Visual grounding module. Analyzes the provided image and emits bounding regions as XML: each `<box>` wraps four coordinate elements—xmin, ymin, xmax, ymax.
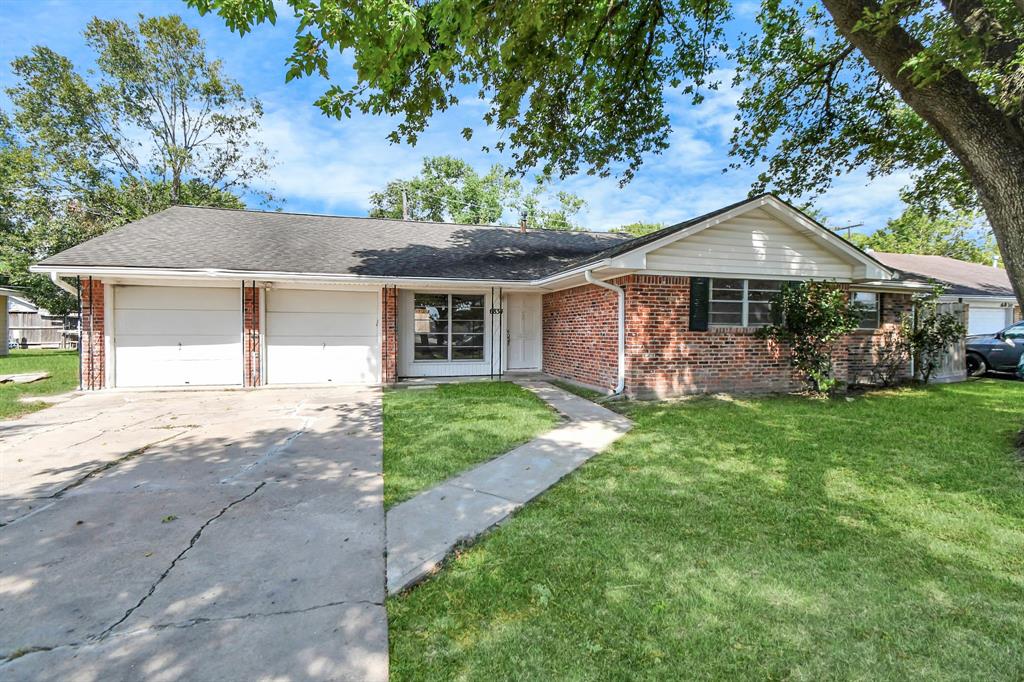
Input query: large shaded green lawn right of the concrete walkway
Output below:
<box><xmin>388</xmin><ymin>380</ymin><xmax>1024</xmax><ymax>680</ymax></box>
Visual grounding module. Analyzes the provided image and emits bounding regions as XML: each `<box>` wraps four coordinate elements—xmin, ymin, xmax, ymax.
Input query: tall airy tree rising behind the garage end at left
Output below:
<box><xmin>0</xmin><ymin>16</ymin><xmax>270</xmax><ymax>312</ymax></box>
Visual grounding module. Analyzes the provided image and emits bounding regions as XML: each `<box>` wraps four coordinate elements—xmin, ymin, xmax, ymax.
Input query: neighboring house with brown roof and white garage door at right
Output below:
<box><xmin>871</xmin><ymin>251</ymin><xmax>1021</xmax><ymax>335</ymax></box>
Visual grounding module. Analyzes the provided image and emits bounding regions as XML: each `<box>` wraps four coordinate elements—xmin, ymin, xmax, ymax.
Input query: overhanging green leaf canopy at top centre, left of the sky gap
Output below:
<box><xmin>189</xmin><ymin>0</ymin><xmax>729</xmax><ymax>180</ymax></box>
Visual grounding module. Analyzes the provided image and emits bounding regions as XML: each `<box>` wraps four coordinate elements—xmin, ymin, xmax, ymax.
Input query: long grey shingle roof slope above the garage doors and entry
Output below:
<box><xmin>40</xmin><ymin>206</ymin><xmax>631</xmax><ymax>281</ymax></box>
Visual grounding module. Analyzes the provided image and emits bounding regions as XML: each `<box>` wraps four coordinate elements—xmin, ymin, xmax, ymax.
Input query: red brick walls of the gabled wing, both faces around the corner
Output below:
<box><xmin>544</xmin><ymin>275</ymin><xmax>911</xmax><ymax>397</ymax></box>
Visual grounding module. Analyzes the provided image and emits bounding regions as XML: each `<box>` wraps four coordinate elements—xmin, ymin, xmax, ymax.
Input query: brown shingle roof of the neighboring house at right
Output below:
<box><xmin>871</xmin><ymin>251</ymin><xmax>1014</xmax><ymax>296</ymax></box>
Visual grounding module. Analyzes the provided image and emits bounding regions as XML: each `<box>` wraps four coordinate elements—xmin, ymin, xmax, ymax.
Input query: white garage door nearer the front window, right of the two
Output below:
<box><xmin>266</xmin><ymin>289</ymin><xmax>380</xmax><ymax>384</ymax></box>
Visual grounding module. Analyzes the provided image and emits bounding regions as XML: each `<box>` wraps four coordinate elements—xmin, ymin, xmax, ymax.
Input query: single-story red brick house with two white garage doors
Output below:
<box><xmin>33</xmin><ymin>195</ymin><xmax>927</xmax><ymax>396</ymax></box>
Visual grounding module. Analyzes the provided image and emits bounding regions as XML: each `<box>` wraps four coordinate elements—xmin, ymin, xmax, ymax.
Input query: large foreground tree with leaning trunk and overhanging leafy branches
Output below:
<box><xmin>188</xmin><ymin>0</ymin><xmax>1024</xmax><ymax>298</ymax></box>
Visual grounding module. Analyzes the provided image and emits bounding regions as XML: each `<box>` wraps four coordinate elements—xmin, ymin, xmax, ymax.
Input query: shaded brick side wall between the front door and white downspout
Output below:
<box><xmin>543</xmin><ymin>285</ymin><xmax>618</xmax><ymax>390</ymax></box>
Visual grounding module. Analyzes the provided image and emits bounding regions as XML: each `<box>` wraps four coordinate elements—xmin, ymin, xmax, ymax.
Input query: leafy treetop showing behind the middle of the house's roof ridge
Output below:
<box><xmin>370</xmin><ymin>156</ymin><xmax>585</xmax><ymax>230</ymax></box>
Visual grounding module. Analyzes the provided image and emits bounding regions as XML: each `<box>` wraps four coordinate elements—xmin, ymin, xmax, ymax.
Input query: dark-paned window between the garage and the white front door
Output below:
<box><xmin>413</xmin><ymin>294</ymin><xmax>484</xmax><ymax>361</ymax></box>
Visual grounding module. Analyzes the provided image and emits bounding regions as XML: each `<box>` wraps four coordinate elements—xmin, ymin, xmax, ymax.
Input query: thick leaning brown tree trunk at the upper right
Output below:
<box><xmin>823</xmin><ymin>0</ymin><xmax>1024</xmax><ymax>302</ymax></box>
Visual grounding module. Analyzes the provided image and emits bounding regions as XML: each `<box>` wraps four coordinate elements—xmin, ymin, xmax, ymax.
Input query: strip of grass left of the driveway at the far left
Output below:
<box><xmin>0</xmin><ymin>350</ymin><xmax>78</xmax><ymax>419</ymax></box>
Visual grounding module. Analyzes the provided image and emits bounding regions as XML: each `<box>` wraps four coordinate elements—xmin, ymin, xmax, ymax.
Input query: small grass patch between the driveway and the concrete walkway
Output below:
<box><xmin>384</xmin><ymin>382</ymin><xmax>558</xmax><ymax>507</ymax></box>
